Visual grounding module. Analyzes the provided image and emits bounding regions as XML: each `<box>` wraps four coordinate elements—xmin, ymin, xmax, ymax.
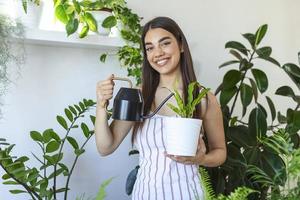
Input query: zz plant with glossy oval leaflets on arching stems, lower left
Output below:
<box><xmin>0</xmin><ymin>99</ymin><xmax>95</xmax><ymax>200</ymax></box>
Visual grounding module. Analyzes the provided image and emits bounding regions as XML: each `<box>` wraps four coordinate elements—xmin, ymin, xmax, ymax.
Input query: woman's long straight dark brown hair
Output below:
<box><xmin>131</xmin><ymin>17</ymin><xmax>200</xmax><ymax>144</ymax></box>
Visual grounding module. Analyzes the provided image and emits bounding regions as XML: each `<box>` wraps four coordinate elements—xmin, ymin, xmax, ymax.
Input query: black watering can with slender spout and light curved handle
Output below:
<box><xmin>112</xmin><ymin>77</ymin><xmax>174</xmax><ymax>122</ymax></box>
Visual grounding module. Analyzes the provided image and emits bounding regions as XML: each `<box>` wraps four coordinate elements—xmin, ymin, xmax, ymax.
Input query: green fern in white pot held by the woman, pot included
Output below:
<box><xmin>165</xmin><ymin>82</ymin><xmax>209</xmax><ymax>156</ymax></box>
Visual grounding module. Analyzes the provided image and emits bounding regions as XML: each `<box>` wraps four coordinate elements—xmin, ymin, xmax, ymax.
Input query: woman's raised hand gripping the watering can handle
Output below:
<box><xmin>96</xmin><ymin>74</ymin><xmax>115</xmax><ymax>108</ymax></box>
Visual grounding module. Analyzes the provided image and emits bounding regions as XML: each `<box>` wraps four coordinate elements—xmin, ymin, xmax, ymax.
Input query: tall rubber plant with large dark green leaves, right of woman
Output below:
<box><xmin>209</xmin><ymin>24</ymin><xmax>300</xmax><ymax>199</ymax></box>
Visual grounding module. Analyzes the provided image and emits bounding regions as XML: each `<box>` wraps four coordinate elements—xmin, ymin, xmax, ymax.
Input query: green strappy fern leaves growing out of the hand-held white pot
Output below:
<box><xmin>167</xmin><ymin>81</ymin><xmax>210</xmax><ymax>118</ymax></box>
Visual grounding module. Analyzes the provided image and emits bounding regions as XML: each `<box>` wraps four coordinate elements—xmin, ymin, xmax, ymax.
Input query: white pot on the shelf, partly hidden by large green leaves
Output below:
<box><xmin>89</xmin><ymin>10</ymin><xmax>112</xmax><ymax>36</ymax></box>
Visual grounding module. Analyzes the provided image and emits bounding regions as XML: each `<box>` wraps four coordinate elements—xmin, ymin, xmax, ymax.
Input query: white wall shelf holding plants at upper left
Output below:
<box><xmin>25</xmin><ymin>28</ymin><xmax>125</xmax><ymax>50</ymax></box>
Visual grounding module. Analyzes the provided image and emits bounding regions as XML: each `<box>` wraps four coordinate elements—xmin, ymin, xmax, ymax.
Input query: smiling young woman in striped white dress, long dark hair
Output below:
<box><xmin>95</xmin><ymin>17</ymin><xmax>226</xmax><ymax>200</ymax></box>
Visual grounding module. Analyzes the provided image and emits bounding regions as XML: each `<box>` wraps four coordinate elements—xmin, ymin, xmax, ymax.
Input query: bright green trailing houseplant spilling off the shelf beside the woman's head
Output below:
<box><xmin>54</xmin><ymin>0</ymin><xmax>143</xmax><ymax>84</ymax></box>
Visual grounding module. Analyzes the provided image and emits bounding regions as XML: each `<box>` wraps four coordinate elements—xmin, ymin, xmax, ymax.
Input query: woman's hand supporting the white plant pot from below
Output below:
<box><xmin>165</xmin><ymin>136</ymin><xmax>206</xmax><ymax>165</ymax></box>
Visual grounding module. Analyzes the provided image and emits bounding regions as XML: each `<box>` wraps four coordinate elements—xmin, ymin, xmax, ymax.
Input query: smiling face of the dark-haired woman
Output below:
<box><xmin>144</xmin><ymin>28</ymin><xmax>180</xmax><ymax>75</ymax></box>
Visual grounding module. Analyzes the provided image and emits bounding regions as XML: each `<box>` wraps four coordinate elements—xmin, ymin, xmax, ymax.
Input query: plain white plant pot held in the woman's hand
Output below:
<box><xmin>164</xmin><ymin>117</ymin><xmax>202</xmax><ymax>156</ymax></box>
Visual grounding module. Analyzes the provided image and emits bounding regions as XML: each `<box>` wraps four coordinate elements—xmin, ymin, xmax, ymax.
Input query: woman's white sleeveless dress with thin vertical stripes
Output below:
<box><xmin>132</xmin><ymin>115</ymin><xmax>204</xmax><ymax>200</ymax></box>
